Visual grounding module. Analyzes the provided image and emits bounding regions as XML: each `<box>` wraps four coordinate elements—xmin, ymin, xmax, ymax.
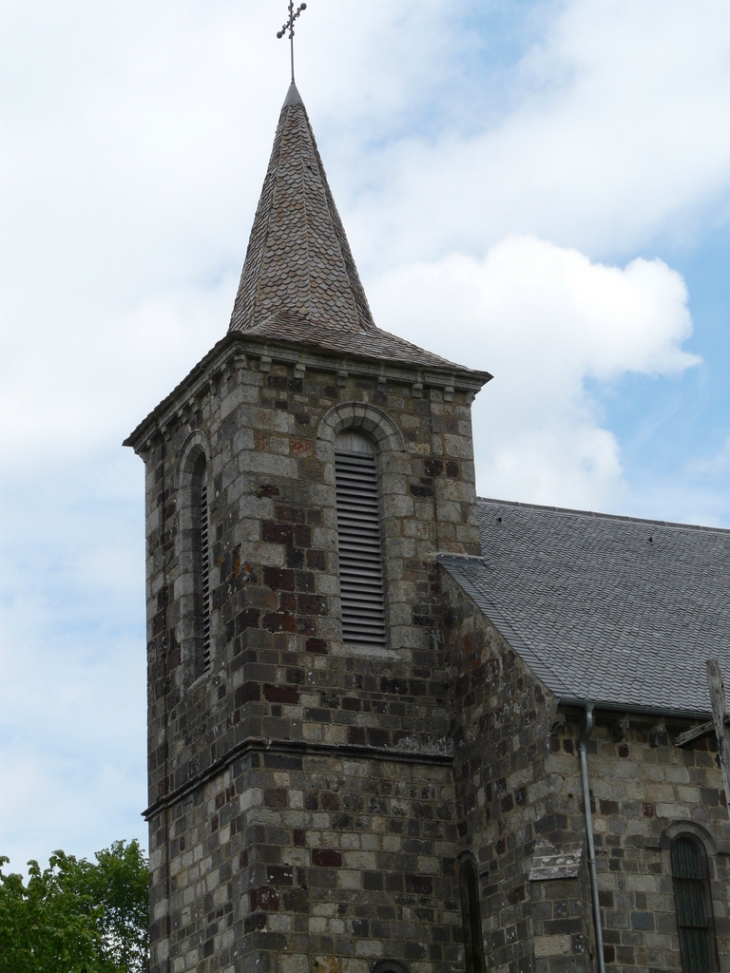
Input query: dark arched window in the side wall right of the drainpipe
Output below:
<box><xmin>671</xmin><ymin>834</ymin><xmax>718</xmax><ymax>973</ymax></box>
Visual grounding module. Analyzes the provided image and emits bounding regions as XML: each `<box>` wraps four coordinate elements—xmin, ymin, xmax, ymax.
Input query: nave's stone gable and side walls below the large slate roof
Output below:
<box><xmin>444</xmin><ymin>578</ymin><xmax>730</xmax><ymax>973</ymax></box>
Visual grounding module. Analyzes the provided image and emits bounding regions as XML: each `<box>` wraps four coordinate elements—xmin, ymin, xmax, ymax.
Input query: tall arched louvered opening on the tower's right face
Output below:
<box><xmin>335</xmin><ymin>430</ymin><xmax>386</xmax><ymax>648</ymax></box>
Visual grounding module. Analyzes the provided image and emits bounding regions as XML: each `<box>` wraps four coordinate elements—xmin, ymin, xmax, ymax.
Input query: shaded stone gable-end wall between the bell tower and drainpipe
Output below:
<box><xmin>444</xmin><ymin>577</ymin><xmax>595</xmax><ymax>973</ymax></box>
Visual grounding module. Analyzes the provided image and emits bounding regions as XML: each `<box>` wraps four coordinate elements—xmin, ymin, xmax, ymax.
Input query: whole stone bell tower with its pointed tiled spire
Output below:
<box><xmin>125</xmin><ymin>84</ymin><xmax>489</xmax><ymax>973</ymax></box>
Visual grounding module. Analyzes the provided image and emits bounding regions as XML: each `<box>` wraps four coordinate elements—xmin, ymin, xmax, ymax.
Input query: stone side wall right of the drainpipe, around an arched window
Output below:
<box><xmin>547</xmin><ymin>711</ymin><xmax>730</xmax><ymax>973</ymax></box>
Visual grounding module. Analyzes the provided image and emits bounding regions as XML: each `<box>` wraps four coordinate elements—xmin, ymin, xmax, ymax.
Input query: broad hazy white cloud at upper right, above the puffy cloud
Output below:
<box><xmin>360</xmin><ymin>0</ymin><xmax>730</xmax><ymax>268</ymax></box>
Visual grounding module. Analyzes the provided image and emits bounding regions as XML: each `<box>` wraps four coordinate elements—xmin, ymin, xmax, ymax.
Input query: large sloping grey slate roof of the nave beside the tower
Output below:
<box><xmin>439</xmin><ymin>499</ymin><xmax>730</xmax><ymax>717</ymax></box>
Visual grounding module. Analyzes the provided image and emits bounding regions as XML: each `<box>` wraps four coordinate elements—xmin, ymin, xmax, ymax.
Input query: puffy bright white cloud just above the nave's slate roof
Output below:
<box><xmin>372</xmin><ymin>237</ymin><xmax>698</xmax><ymax>509</ymax></box>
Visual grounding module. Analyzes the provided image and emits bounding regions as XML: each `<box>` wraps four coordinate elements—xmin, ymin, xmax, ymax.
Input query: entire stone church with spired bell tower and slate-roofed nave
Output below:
<box><xmin>125</xmin><ymin>83</ymin><xmax>730</xmax><ymax>973</ymax></box>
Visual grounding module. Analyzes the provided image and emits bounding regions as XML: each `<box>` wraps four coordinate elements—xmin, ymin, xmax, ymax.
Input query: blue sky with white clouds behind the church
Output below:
<box><xmin>0</xmin><ymin>0</ymin><xmax>730</xmax><ymax>870</ymax></box>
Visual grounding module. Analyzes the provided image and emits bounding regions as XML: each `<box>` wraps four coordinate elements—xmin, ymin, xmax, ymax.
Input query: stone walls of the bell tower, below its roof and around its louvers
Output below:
<box><xmin>134</xmin><ymin>342</ymin><xmax>479</xmax><ymax>973</ymax></box>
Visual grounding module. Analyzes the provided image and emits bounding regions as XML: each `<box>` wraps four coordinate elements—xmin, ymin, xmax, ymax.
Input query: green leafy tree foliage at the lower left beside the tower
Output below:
<box><xmin>0</xmin><ymin>841</ymin><xmax>149</xmax><ymax>973</ymax></box>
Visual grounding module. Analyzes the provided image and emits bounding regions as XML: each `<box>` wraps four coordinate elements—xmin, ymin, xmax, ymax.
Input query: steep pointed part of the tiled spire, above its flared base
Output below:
<box><xmin>230</xmin><ymin>88</ymin><xmax>377</xmax><ymax>337</ymax></box>
